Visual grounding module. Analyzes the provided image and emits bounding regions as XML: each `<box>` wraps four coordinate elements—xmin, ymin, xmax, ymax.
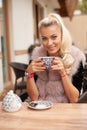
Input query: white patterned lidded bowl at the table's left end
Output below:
<box><xmin>2</xmin><ymin>90</ymin><xmax>22</xmax><ymax>112</ymax></box>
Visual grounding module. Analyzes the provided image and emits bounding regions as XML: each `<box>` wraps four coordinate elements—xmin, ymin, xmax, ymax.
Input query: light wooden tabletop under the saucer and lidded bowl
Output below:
<box><xmin>0</xmin><ymin>102</ymin><xmax>87</xmax><ymax>130</ymax></box>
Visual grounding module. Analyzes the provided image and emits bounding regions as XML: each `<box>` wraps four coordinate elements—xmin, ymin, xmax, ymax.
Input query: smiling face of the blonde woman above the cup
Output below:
<box><xmin>40</xmin><ymin>24</ymin><xmax>62</xmax><ymax>56</ymax></box>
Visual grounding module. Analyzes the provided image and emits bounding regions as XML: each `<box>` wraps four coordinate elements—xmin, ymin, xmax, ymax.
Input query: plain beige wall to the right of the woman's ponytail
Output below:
<box><xmin>64</xmin><ymin>15</ymin><xmax>87</xmax><ymax>52</ymax></box>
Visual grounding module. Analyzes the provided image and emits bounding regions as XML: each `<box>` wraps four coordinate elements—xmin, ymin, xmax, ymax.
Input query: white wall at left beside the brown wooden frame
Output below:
<box><xmin>9</xmin><ymin>0</ymin><xmax>34</xmax><ymax>62</ymax></box>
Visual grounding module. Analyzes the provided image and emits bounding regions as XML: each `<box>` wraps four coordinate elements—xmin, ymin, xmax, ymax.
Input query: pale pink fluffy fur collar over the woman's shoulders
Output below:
<box><xmin>31</xmin><ymin>46</ymin><xmax>86</xmax><ymax>77</ymax></box>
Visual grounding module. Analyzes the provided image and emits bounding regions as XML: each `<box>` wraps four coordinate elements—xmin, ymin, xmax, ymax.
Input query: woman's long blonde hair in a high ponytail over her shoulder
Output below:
<box><xmin>38</xmin><ymin>13</ymin><xmax>74</xmax><ymax>68</ymax></box>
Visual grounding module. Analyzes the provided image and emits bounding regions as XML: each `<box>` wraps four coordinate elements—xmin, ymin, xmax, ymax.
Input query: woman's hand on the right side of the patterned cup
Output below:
<box><xmin>51</xmin><ymin>57</ymin><xmax>66</xmax><ymax>76</ymax></box>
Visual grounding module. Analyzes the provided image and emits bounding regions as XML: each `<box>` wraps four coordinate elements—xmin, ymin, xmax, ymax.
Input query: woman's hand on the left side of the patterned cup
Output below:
<box><xmin>26</xmin><ymin>58</ymin><xmax>45</xmax><ymax>73</ymax></box>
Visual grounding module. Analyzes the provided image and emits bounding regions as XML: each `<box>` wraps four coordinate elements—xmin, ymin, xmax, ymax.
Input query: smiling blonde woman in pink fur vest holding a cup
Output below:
<box><xmin>26</xmin><ymin>13</ymin><xmax>85</xmax><ymax>103</ymax></box>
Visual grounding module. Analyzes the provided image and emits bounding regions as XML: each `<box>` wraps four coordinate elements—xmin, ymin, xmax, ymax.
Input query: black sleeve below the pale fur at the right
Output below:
<box><xmin>72</xmin><ymin>61</ymin><xmax>84</xmax><ymax>92</ymax></box>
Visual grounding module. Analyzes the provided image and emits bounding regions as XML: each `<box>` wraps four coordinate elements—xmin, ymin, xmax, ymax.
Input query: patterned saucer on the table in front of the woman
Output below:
<box><xmin>28</xmin><ymin>100</ymin><xmax>53</xmax><ymax>110</ymax></box>
